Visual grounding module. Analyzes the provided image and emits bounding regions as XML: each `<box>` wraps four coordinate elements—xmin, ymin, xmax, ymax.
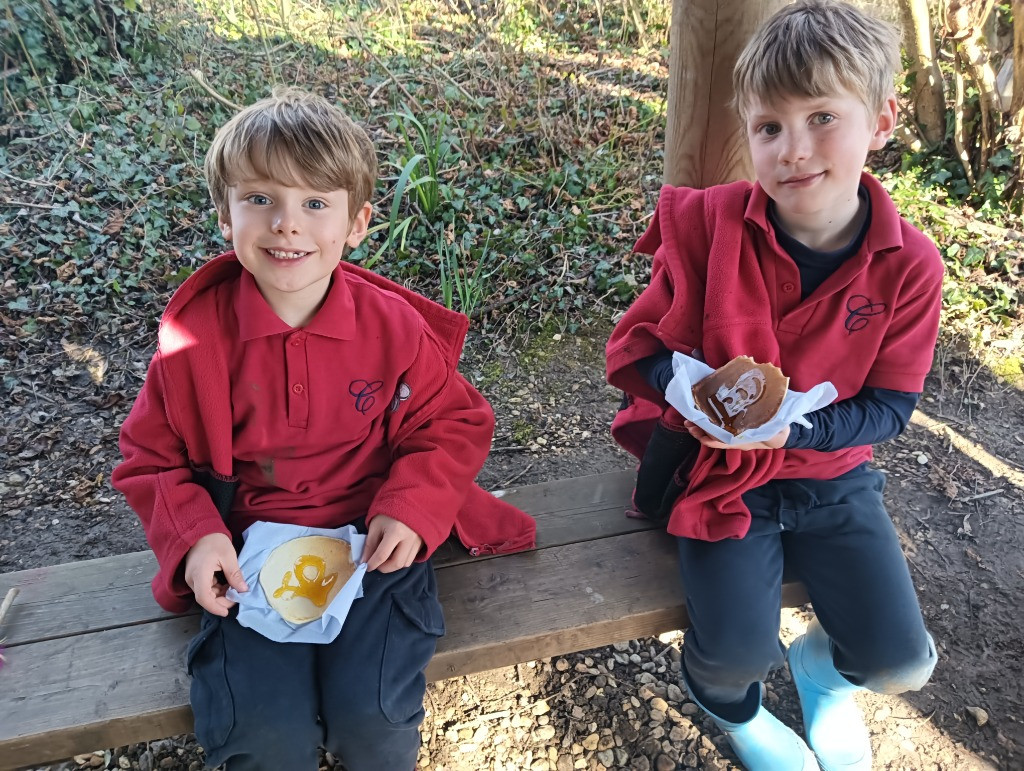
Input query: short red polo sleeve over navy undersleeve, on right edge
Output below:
<box><xmin>864</xmin><ymin>246</ymin><xmax>943</xmax><ymax>392</ymax></box>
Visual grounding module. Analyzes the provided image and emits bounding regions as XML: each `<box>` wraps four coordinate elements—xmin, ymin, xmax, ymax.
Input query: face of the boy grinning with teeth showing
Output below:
<box><xmin>218</xmin><ymin>178</ymin><xmax>371</xmax><ymax>327</ymax></box>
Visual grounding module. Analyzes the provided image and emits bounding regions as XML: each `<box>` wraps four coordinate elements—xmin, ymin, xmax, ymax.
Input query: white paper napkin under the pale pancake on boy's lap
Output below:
<box><xmin>226</xmin><ymin>522</ymin><xmax>367</xmax><ymax>643</ymax></box>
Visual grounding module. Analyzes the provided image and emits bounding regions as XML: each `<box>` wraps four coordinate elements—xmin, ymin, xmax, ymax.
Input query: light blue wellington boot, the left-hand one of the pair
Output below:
<box><xmin>684</xmin><ymin>678</ymin><xmax>818</xmax><ymax>771</ymax></box>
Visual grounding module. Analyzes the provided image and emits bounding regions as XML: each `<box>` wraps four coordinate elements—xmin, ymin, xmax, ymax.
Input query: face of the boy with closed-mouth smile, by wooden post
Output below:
<box><xmin>746</xmin><ymin>91</ymin><xmax>896</xmax><ymax>243</ymax></box>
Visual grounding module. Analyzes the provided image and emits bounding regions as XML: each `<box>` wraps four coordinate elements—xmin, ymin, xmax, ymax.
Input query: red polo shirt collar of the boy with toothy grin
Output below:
<box><xmin>234</xmin><ymin>262</ymin><xmax>355</xmax><ymax>341</ymax></box>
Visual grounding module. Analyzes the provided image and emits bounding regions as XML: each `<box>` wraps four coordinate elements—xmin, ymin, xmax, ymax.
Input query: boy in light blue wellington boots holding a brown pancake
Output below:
<box><xmin>607</xmin><ymin>0</ymin><xmax>943</xmax><ymax>771</ymax></box>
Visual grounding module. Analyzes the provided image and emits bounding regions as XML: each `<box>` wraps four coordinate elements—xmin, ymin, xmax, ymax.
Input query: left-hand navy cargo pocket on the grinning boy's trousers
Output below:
<box><xmin>185</xmin><ymin>611</ymin><xmax>234</xmax><ymax>753</ymax></box>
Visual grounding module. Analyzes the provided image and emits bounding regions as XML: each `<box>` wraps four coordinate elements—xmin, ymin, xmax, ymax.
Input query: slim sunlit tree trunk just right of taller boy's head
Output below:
<box><xmin>899</xmin><ymin>0</ymin><xmax>946</xmax><ymax>147</ymax></box>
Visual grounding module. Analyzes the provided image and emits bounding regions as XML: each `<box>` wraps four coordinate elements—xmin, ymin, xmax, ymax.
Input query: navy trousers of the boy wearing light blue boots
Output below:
<box><xmin>677</xmin><ymin>464</ymin><xmax>936</xmax><ymax>723</ymax></box>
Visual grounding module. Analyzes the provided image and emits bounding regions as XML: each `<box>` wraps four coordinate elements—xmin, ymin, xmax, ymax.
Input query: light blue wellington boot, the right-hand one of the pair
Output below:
<box><xmin>787</xmin><ymin>618</ymin><xmax>871</xmax><ymax>771</ymax></box>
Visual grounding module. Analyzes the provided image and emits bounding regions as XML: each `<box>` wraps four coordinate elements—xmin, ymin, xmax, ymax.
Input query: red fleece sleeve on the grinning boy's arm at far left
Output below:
<box><xmin>111</xmin><ymin>351</ymin><xmax>230</xmax><ymax>612</ymax></box>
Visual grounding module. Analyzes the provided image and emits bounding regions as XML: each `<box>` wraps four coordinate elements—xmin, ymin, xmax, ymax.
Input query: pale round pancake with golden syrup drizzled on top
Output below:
<box><xmin>259</xmin><ymin>536</ymin><xmax>355</xmax><ymax>624</ymax></box>
